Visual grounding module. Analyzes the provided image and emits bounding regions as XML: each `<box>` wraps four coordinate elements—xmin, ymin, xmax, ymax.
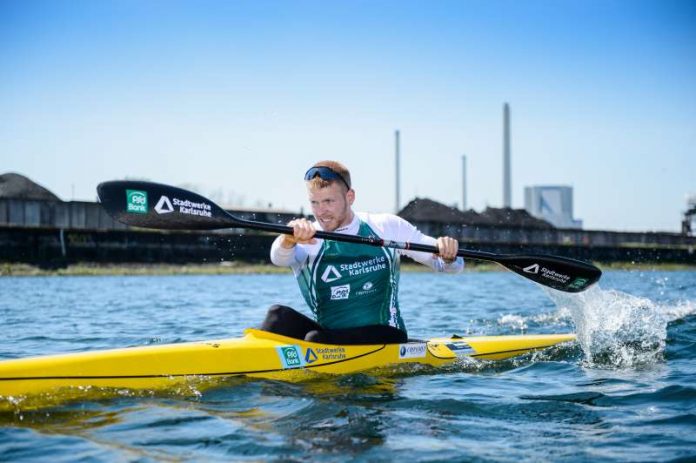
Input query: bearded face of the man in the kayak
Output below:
<box><xmin>307</xmin><ymin>182</ymin><xmax>355</xmax><ymax>231</ymax></box>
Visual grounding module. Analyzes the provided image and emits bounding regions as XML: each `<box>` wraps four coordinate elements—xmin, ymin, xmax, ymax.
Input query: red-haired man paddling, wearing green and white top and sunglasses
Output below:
<box><xmin>261</xmin><ymin>161</ymin><xmax>464</xmax><ymax>344</ymax></box>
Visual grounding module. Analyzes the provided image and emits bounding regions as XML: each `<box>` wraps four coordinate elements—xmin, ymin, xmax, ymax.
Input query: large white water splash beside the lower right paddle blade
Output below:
<box><xmin>547</xmin><ymin>285</ymin><xmax>696</xmax><ymax>368</ymax></box>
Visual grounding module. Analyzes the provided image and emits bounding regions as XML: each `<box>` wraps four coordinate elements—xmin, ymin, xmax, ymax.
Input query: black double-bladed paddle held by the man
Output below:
<box><xmin>97</xmin><ymin>180</ymin><xmax>602</xmax><ymax>293</ymax></box>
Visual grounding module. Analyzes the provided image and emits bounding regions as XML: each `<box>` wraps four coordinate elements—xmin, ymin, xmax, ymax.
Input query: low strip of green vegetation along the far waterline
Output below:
<box><xmin>0</xmin><ymin>261</ymin><xmax>696</xmax><ymax>276</ymax></box>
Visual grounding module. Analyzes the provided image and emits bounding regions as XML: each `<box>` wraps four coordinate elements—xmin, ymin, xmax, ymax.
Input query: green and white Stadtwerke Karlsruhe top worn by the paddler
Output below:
<box><xmin>271</xmin><ymin>213</ymin><xmax>464</xmax><ymax>331</ymax></box>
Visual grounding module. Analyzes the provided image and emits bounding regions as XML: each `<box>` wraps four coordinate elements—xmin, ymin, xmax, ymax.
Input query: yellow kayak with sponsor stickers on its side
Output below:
<box><xmin>0</xmin><ymin>329</ymin><xmax>575</xmax><ymax>400</ymax></box>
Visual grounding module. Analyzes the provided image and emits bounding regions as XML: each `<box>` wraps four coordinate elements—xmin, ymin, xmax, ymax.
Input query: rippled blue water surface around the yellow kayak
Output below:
<box><xmin>0</xmin><ymin>271</ymin><xmax>696</xmax><ymax>462</ymax></box>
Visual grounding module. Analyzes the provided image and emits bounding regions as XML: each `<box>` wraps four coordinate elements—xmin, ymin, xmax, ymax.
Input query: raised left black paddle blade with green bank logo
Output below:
<box><xmin>97</xmin><ymin>180</ymin><xmax>236</xmax><ymax>230</ymax></box>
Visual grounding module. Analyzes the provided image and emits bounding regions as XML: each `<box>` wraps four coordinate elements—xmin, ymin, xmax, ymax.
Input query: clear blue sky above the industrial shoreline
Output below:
<box><xmin>0</xmin><ymin>0</ymin><xmax>696</xmax><ymax>231</ymax></box>
